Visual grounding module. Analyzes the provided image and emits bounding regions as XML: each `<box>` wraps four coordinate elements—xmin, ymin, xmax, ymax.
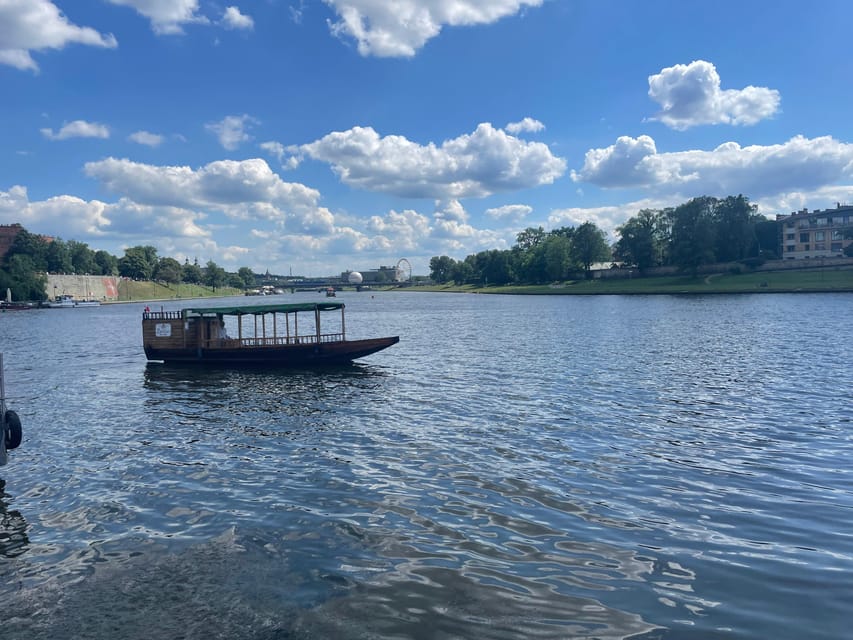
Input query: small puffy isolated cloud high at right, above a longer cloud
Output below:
<box><xmin>649</xmin><ymin>60</ymin><xmax>780</xmax><ymax>130</ymax></box>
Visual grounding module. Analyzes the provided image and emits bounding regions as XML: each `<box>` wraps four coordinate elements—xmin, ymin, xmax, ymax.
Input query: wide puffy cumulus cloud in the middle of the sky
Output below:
<box><xmin>288</xmin><ymin>123</ymin><xmax>566</xmax><ymax>199</ymax></box>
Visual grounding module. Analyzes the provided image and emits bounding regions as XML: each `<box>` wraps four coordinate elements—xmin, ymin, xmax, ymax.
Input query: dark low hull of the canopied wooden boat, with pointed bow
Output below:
<box><xmin>144</xmin><ymin>336</ymin><xmax>400</xmax><ymax>367</ymax></box>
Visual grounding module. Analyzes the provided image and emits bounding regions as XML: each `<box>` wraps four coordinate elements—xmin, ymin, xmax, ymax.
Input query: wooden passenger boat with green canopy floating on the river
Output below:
<box><xmin>142</xmin><ymin>301</ymin><xmax>400</xmax><ymax>366</ymax></box>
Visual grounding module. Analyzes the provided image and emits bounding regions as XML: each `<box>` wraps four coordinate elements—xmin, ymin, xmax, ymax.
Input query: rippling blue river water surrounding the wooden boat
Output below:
<box><xmin>0</xmin><ymin>292</ymin><xmax>853</xmax><ymax>640</ymax></box>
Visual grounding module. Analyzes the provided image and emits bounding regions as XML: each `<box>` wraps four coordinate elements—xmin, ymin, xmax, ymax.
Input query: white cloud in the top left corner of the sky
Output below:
<box><xmin>0</xmin><ymin>0</ymin><xmax>118</xmax><ymax>71</ymax></box>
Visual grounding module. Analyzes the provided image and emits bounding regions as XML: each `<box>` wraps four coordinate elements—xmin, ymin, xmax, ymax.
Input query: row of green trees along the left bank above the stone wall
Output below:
<box><xmin>0</xmin><ymin>229</ymin><xmax>255</xmax><ymax>300</ymax></box>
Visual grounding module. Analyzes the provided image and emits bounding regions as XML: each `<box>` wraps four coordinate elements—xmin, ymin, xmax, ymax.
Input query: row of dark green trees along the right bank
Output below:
<box><xmin>429</xmin><ymin>195</ymin><xmax>779</xmax><ymax>285</ymax></box>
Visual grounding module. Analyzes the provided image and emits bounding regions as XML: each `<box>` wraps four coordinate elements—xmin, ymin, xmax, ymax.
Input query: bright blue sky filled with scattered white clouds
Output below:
<box><xmin>0</xmin><ymin>0</ymin><xmax>853</xmax><ymax>276</ymax></box>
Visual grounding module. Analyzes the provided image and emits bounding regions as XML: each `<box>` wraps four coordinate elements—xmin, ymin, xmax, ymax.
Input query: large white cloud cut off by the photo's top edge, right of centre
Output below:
<box><xmin>324</xmin><ymin>0</ymin><xmax>543</xmax><ymax>57</ymax></box>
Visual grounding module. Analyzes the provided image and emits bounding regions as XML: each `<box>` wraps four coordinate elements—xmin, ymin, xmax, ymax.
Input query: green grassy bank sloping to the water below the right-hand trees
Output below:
<box><xmin>408</xmin><ymin>267</ymin><xmax>853</xmax><ymax>295</ymax></box>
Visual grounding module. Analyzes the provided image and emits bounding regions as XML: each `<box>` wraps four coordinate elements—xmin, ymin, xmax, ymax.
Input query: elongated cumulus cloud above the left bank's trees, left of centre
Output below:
<box><xmin>80</xmin><ymin>158</ymin><xmax>334</xmax><ymax>233</ymax></box>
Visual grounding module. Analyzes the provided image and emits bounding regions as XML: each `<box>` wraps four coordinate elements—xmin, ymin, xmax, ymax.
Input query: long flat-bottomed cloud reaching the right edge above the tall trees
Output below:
<box><xmin>571</xmin><ymin>136</ymin><xmax>853</xmax><ymax>198</ymax></box>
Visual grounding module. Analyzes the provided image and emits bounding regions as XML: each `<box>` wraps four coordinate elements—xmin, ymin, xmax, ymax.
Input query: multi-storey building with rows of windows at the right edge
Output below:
<box><xmin>776</xmin><ymin>202</ymin><xmax>853</xmax><ymax>260</ymax></box>
